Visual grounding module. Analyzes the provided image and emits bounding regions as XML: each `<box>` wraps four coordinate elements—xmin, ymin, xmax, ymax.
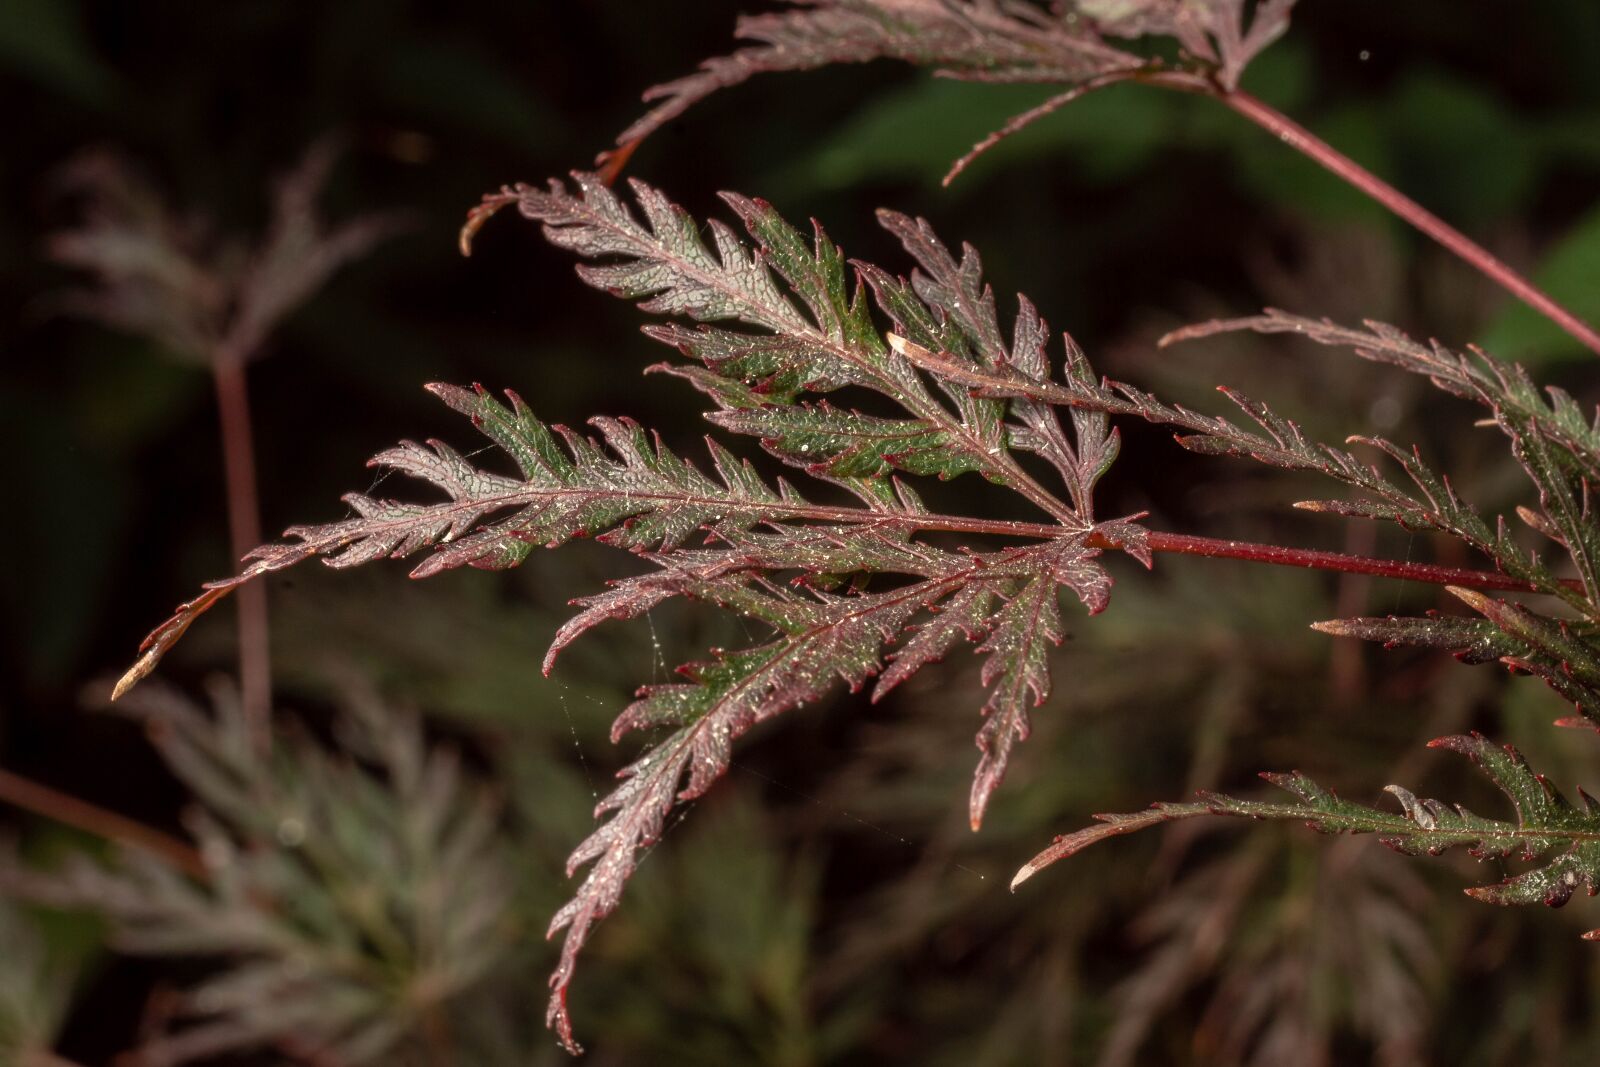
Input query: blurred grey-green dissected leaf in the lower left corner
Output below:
<box><xmin>0</xmin><ymin>689</ymin><xmax>518</xmax><ymax>1065</ymax></box>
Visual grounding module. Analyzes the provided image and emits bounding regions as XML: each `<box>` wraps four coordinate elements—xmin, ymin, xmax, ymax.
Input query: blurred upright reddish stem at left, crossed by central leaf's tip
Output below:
<box><xmin>211</xmin><ymin>352</ymin><xmax>272</xmax><ymax>750</ymax></box>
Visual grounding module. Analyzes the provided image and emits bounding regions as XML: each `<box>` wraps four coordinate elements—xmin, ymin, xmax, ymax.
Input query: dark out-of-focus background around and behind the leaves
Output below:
<box><xmin>9</xmin><ymin>0</ymin><xmax>1600</xmax><ymax>1065</ymax></box>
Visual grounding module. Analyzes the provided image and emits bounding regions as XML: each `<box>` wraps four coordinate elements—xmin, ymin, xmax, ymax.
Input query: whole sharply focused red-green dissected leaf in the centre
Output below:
<box><xmin>128</xmin><ymin>174</ymin><xmax>1177</xmax><ymax>1048</ymax></box>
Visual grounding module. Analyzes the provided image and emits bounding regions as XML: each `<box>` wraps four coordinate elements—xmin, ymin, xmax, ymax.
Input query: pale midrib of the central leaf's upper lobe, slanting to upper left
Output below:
<box><xmin>540</xmin><ymin>184</ymin><xmax>1077</xmax><ymax>523</ymax></box>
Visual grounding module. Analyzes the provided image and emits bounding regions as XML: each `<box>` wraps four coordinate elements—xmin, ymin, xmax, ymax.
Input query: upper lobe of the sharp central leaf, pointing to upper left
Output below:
<box><xmin>485</xmin><ymin>174</ymin><xmax>1070</xmax><ymax>518</ymax></box>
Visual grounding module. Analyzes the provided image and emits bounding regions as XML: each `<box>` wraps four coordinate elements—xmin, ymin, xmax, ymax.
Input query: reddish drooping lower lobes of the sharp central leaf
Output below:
<box><xmin>547</xmin><ymin>534</ymin><xmax>1110</xmax><ymax>1049</ymax></box>
